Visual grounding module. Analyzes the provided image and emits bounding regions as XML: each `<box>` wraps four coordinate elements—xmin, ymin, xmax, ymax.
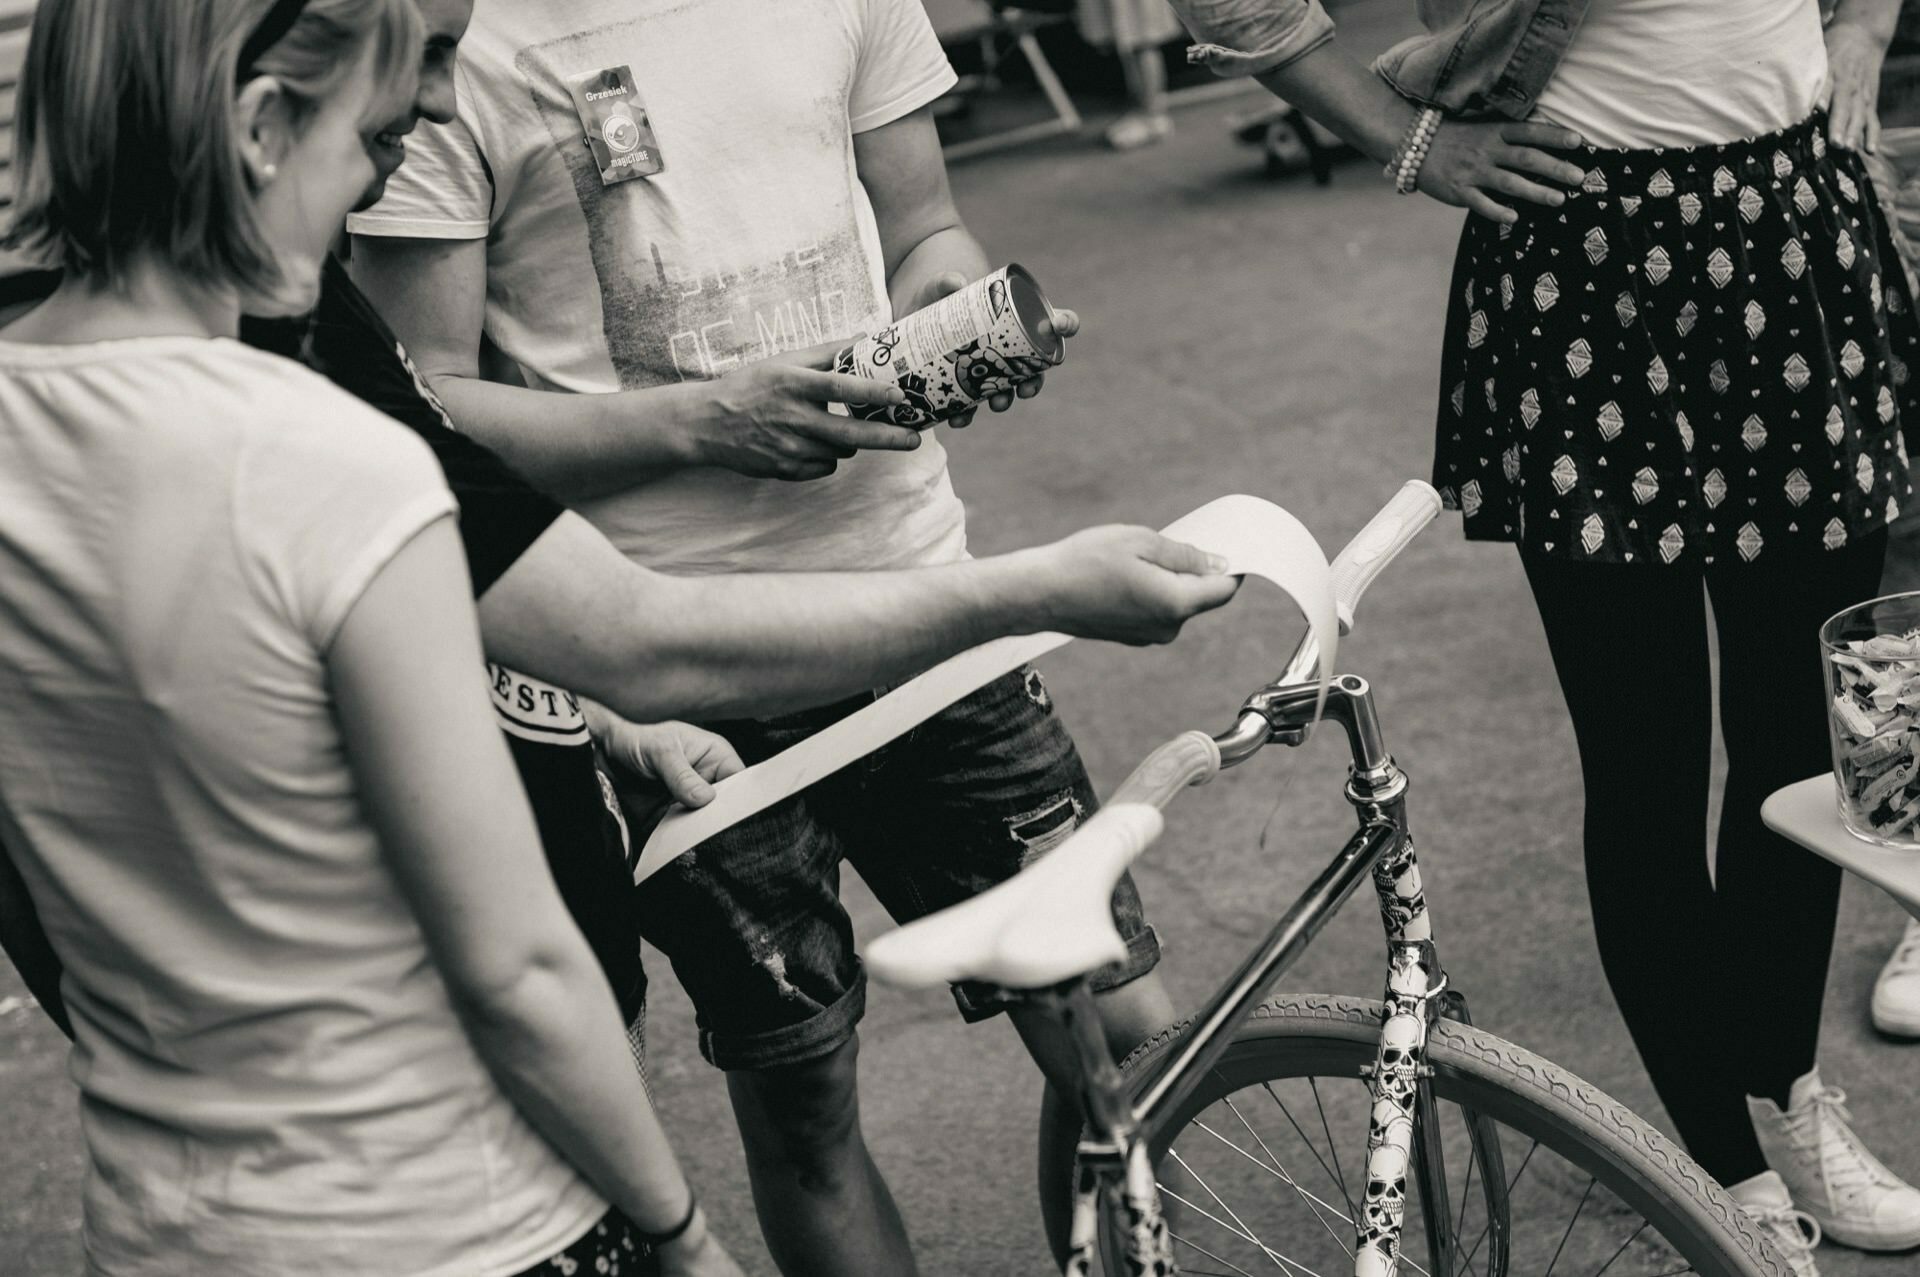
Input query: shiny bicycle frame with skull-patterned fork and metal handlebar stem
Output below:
<box><xmin>1035</xmin><ymin>672</ymin><xmax>1507</xmax><ymax>1277</ymax></box>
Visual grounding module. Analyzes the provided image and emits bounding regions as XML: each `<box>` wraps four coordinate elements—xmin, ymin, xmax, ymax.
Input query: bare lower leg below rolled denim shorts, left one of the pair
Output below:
<box><xmin>726</xmin><ymin>1039</ymin><xmax>920</xmax><ymax>1277</ymax></box>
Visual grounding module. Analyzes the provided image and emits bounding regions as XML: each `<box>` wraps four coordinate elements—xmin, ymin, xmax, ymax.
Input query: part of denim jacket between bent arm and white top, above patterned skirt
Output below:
<box><xmin>1373</xmin><ymin>0</ymin><xmax>1590</xmax><ymax>119</ymax></box>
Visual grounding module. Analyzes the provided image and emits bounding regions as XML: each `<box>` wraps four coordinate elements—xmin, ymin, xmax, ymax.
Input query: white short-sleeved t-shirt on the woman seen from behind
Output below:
<box><xmin>0</xmin><ymin>338</ymin><xmax>605</xmax><ymax>1277</ymax></box>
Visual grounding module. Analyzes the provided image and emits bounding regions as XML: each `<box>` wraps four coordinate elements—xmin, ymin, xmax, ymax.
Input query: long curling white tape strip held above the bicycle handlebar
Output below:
<box><xmin>634</xmin><ymin>495</ymin><xmax>1340</xmax><ymax>881</ymax></box>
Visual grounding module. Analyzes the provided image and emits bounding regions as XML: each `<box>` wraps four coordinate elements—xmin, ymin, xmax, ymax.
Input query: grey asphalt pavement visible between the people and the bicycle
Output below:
<box><xmin>0</xmin><ymin>22</ymin><xmax>1920</xmax><ymax>1277</ymax></box>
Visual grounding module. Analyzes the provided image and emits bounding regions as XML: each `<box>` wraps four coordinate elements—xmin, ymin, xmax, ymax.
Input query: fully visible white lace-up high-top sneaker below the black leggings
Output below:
<box><xmin>1747</xmin><ymin>1070</ymin><xmax>1920</xmax><ymax>1250</ymax></box>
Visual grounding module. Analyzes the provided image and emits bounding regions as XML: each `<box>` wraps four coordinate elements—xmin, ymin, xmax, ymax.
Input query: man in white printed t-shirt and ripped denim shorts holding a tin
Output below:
<box><xmin>349</xmin><ymin>0</ymin><xmax>1171</xmax><ymax>1275</ymax></box>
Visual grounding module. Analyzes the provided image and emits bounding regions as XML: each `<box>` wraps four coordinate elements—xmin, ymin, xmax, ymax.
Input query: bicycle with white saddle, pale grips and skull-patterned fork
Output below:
<box><xmin>866</xmin><ymin>482</ymin><xmax>1788</xmax><ymax>1277</ymax></box>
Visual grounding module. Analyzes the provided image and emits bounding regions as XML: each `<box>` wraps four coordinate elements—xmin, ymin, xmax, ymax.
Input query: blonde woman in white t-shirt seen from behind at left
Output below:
<box><xmin>0</xmin><ymin>0</ymin><xmax>739</xmax><ymax>1277</ymax></box>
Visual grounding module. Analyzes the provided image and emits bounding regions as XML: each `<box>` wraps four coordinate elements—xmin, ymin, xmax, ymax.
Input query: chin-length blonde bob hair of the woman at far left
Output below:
<box><xmin>4</xmin><ymin>0</ymin><xmax>420</xmax><ymax>294</ymax></box>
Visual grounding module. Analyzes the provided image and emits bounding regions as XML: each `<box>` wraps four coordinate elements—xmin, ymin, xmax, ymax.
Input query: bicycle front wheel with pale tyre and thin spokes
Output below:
<box><xmin>1052</xmin><ymin>995</ymin><xmax>1788</xmax><ymax>1277</ymax></box>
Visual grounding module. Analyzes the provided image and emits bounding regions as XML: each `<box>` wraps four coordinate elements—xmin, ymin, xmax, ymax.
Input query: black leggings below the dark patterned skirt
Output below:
<box><xmin>1521</xmin><ymin>532</ymin><xmax>1887</xmax><ymax>1185</ymax></box>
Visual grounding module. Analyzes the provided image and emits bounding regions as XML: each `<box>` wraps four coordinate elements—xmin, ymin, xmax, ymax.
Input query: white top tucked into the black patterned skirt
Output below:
<box><xmin>1534</xmin><ymin>0</ymin><xmax>1826</xmax><ymax>150</ymax></box>
